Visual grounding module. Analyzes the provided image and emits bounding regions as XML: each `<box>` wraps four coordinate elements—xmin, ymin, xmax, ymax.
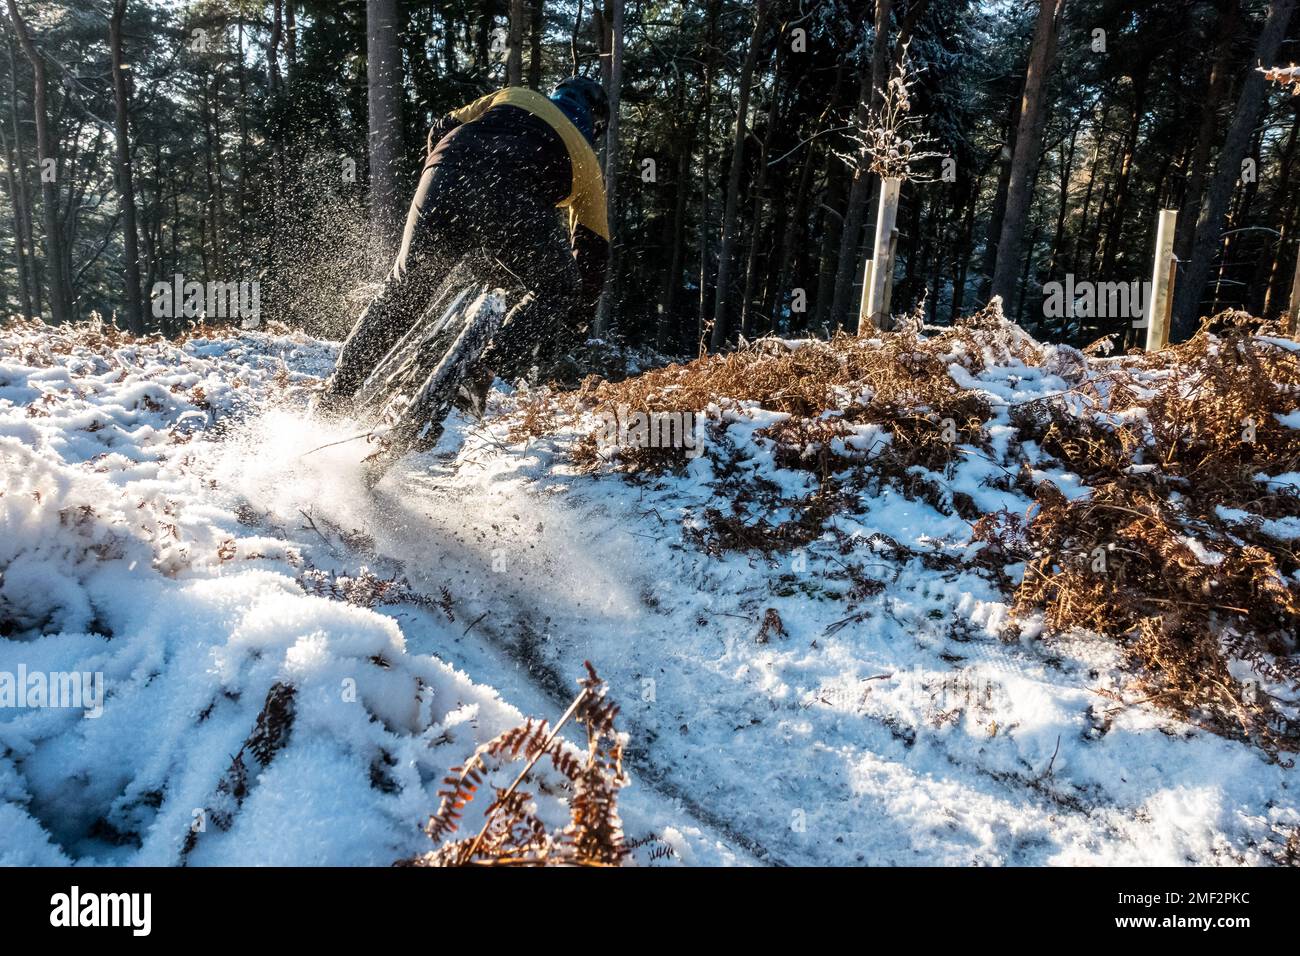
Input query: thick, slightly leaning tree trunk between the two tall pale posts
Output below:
<box><xmin>992</xmin><ymin>0</ymin><xmax>1065</xmax><ymax>303</ymax></box>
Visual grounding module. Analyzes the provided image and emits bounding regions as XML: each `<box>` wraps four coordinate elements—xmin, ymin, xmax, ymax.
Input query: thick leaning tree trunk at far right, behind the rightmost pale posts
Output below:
<box><xmin>1170</xmin><ymin>0</ymin><xmax>1295</xmax><ymax>341</ymax></box>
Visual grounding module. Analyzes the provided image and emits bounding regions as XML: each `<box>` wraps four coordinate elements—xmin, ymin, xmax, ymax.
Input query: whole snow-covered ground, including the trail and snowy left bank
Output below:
<box><xmin>0</xmin><ymin>321</ymin><xmax>1300</xmax><ymax>865</ymax></box>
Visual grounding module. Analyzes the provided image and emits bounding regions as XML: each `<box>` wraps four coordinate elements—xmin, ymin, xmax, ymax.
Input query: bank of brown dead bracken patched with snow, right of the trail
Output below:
<box><xmin>517</xmin><ymin>302</ymin><xmax>1300</xmax><ymax>760</ymax></box>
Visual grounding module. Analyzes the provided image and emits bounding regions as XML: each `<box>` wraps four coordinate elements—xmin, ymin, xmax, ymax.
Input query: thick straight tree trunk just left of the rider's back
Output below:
<box><xmin>365</xmin><ymin>0</ymin><xmax>402</xmax><ymax>256</ymax></box>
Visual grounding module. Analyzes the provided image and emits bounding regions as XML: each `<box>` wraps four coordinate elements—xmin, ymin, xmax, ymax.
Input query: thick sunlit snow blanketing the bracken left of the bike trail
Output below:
<box><xmin>0</xmin><ymin>326</ymin><xmax>729</xmax><ymax>865</ymax></box>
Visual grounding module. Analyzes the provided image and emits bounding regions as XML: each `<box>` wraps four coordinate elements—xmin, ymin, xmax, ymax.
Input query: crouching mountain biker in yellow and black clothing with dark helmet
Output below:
<box><xmin>320</xmin><ymin>77</ymin><xmax>610</xmax><ymax>411</ymax></box>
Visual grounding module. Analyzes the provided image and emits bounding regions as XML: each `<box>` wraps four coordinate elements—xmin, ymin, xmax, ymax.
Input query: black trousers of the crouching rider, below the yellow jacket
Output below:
<box><xmin>326</xmin><ymin>151</ymin><xmax>585</xmax><ymax>401</ymax></box>
